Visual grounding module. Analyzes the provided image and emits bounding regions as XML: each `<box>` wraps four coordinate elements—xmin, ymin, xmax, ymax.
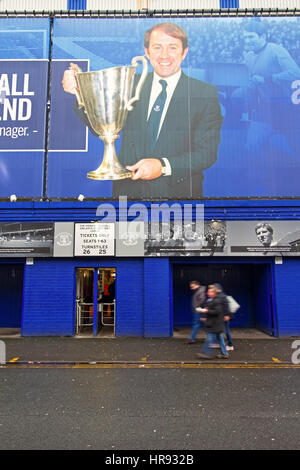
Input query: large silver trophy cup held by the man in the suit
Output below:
<box><xmin>76</xmin><ymin>56</ymin><xmax>148</xmax><ymax>180</ymax></box>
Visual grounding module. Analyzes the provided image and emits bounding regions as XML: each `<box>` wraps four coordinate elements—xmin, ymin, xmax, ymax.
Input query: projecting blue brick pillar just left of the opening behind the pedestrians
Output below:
<box><xmin>144</xmin><ymin>258</ymin><xmax>171</xmax><ymax>337</ymax></box>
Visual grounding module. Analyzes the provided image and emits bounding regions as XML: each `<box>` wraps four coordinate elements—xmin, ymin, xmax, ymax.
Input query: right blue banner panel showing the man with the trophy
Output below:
<box><xmin>48</xmin><ymin>17</ymin><xmax>300</xmax><ymax>200</ymax></box>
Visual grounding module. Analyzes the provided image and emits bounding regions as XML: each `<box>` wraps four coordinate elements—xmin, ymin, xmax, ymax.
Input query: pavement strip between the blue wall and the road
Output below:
<box><xmin>0</xmin><ymin>329</ymin><xmax>300</xmax><ymax>367</ymax></box>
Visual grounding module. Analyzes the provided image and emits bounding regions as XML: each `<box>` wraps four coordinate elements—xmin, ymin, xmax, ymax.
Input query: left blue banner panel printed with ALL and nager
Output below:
<box><xmin>0</xmin><ymin>18</ymin><xmax>49</xmax><ymax>198</ymax></box>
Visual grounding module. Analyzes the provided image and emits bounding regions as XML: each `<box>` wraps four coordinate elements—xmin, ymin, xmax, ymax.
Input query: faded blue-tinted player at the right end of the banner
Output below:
<box><xmin>229</xmin><ymin>18</ymin><xmax>300</xmax><ymax>162</ymax></box>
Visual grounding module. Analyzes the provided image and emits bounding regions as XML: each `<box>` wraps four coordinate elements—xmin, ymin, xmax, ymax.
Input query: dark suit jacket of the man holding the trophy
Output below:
<box><xmin>76</xmin><ymin>73</ymin><xmax>223</xmax><ymax>199</ymax></box>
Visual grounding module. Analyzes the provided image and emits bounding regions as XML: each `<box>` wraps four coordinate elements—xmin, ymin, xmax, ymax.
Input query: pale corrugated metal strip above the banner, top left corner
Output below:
<box><xmin>0</xmin><ymin>0</ymin><xmax>68</xmax><ymax>11</ymax></box>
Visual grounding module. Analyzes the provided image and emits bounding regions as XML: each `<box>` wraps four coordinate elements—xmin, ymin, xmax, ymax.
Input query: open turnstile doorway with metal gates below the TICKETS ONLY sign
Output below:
<box><xmin>75</xmin><ymin>268</ymin><xmax>116</xmax><ymax>337</ymax></box>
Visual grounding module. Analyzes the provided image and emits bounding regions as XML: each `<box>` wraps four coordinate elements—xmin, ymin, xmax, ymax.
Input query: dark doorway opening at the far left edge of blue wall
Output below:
<box><xmin>0</xmin><ymin>264</ymin><xmax>24</xmax><ymax>329</ymax></box>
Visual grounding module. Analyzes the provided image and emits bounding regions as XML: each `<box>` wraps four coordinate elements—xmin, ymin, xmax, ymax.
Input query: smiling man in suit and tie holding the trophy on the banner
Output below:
<box><xmin>62</xmin><ymin>23</ymin><xmax>223</xmax><ymax>198</ymax></box>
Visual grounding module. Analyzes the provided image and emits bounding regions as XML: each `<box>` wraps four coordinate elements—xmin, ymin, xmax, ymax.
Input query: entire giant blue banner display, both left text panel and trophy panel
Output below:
<box><xmin>0</xmin><ymin>16</ymin><xmax>300</xmax><ymax>200</ymax></box>
